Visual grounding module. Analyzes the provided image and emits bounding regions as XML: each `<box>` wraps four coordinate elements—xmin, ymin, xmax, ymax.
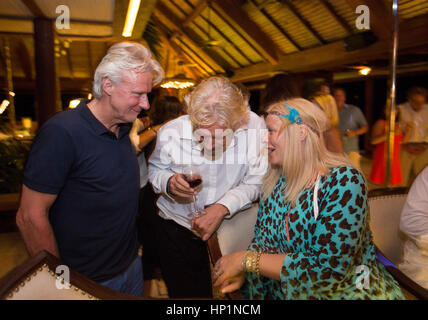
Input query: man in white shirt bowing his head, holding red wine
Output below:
<box><xmin>149</xmin><ymin>77</ymin><xmax>267</xmax><ymax>298</ymax></box>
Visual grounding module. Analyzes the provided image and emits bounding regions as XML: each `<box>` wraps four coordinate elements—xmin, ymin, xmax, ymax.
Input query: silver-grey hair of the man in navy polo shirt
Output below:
<box><xmin>92</xmin><ymin>42</ymin><xmax>165</xmax><ymax>99</ymax></box>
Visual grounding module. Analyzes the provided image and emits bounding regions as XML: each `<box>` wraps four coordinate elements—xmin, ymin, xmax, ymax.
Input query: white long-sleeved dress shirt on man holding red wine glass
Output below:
<box><xmin>149</xmin><ymin>111</ymin><xmax>268</xmax><ymax>229</ymax></box>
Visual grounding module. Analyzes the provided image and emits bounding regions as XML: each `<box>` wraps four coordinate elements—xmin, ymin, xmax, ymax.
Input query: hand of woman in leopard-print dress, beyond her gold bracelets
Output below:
<box><xmin>212</xmin><ymin>251</ymin><xmax>246</xmax><ymax>294</ymax></box>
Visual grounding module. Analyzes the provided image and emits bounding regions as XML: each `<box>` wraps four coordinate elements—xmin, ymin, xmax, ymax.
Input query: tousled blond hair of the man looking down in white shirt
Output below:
<box><xmin>184</xmin><ymin>76</ymin><xmax>250</xmax><ymax>131</ymax></box>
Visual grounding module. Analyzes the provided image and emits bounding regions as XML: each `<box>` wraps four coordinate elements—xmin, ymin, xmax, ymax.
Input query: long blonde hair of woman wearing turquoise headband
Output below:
<box><xmin>262</xmin><ymin>98</ymin><xmax>353</xmax><ymax>206</ymax></box>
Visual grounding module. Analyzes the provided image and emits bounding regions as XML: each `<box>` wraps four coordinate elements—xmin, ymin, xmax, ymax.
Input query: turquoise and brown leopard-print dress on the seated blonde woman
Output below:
<box><xmin>242</xmin><ymin>166</ymin><xmax>404</xmax><ymax>300</ymax></box>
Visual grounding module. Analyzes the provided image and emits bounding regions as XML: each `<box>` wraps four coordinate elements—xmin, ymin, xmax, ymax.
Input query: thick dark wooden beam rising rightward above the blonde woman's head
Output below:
<box><xmin>231</xmin><ymin>14</ymin><xmax>428</xmax><ymax>82</ymax></box>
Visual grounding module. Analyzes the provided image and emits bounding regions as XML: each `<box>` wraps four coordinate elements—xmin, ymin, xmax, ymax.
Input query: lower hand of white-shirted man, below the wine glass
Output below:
<box><xmin>191</xmin><ymin>203</ymin><xmax>229</xmax><ymax>241</ymax></box>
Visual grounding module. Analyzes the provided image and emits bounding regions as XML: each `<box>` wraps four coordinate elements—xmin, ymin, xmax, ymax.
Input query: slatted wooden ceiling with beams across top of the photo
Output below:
<box><xmin>0</xmin><ymin>0</ymin><xmax>428</xmax><ymax>90</ymax></box>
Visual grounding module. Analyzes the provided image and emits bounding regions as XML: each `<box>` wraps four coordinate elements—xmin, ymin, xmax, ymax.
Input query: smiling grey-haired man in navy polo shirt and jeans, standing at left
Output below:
<box><xmin>16</xmin><ymin>42</ymin><xmax>164</xmax><ymax>295</ymax></box>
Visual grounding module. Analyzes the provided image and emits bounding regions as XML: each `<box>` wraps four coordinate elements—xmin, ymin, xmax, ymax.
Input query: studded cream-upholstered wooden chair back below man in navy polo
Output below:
<box><xmin>0</xmin><ymin>251</ymin><xmax>142</xmax><ymax>300</ymax></box>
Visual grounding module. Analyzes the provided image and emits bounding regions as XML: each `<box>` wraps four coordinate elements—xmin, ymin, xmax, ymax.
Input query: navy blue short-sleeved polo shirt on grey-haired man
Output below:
<box><xmin>23</xmin><ymin>101</ymin><xmax>140</xmax><ymax>282</ymax></box>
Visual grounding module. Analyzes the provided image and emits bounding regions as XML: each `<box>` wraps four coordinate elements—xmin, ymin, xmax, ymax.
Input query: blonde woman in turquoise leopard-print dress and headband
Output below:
<box><xmin>213</xmin><ymin>98</ymin><xmax>403</xmax><ymax>299</ymax></box>
